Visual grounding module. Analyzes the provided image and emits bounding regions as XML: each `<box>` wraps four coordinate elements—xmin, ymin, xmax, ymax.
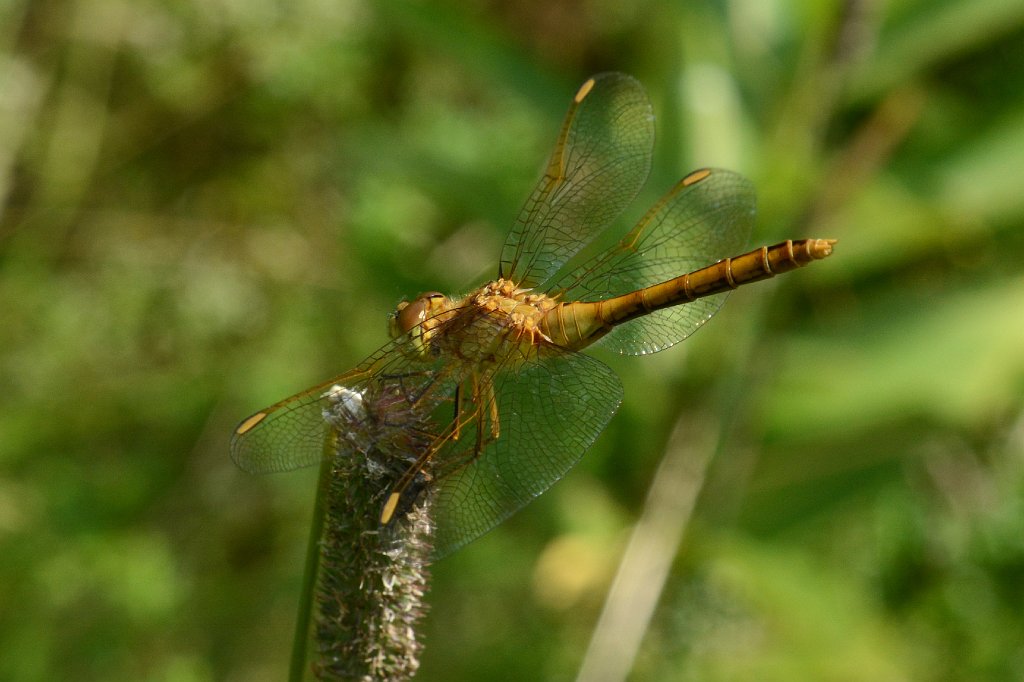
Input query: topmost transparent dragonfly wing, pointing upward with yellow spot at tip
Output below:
<box><xmin>500</xmin><ymin>73</ymin><xmax>654</xmax><ymax>288</ymax></box>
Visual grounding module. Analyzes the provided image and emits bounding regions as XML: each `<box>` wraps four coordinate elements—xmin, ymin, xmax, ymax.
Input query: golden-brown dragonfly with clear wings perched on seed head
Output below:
<box><xmin>230</xmin><ymin>73</ymin><xmax>835</xmax><ymax>558</ymax></box>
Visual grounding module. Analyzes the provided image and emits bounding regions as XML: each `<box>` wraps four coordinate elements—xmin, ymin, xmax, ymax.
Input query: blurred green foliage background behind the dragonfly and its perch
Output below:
<box><xmin>6</xmin><ymin>0</ymin><xmax>1024</xmax><ymax>682</ymax></box>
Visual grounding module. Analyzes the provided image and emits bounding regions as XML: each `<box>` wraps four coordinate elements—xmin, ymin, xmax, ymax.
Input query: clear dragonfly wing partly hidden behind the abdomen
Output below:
<box><xmin>550</xmin><ymin>169</ymin><xmax>757</xmax><ymax>355</ymax></box>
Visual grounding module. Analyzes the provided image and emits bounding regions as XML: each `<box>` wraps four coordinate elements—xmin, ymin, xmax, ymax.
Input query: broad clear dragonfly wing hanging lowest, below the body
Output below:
<box><xmin>425</xmin><ymin>346</ymin><xmax>623</xmax><ymax>558</ymax></box>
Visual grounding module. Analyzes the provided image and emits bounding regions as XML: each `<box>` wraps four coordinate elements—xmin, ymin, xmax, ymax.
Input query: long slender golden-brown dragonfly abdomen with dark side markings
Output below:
<box><xmin>543</xmin><ymin>240</ymin><xmax>836</xmax><ymax>349</ymax></box>
